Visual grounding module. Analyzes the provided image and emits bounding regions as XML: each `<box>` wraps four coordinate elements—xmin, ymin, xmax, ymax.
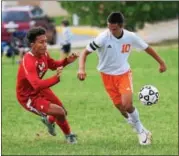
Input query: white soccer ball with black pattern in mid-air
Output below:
<box><xmin>139</xmin><ymin>85</ymin><xmax>159</xmax><ymax>105</ymax></box>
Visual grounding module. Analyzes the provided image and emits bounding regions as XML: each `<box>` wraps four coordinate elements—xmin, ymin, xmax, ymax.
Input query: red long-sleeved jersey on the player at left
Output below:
<box><xmin>16</xmin><ymin>52</ymin><xmax>68</xmax><ymax>104</ymax></box>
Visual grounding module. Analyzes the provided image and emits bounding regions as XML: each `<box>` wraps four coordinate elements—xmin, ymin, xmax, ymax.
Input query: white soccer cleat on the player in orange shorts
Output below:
<box><xmin>138</xmin><ymin>130</ymin><xmax>152</xmax><ymax>145</ymax></box>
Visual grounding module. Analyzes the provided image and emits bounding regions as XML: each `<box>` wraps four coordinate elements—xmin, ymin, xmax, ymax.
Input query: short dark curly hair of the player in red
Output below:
<box><xmin>26</xmin><ymin>27</ymin><xmax>46</xmax><ymax>44</ymax></box>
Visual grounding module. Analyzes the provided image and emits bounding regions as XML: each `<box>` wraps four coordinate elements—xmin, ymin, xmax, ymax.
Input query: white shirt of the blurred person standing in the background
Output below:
<box><xmin>62</xmin><ymin>27</ymin><xmax>72</xmax><ymax>45</ymax></box>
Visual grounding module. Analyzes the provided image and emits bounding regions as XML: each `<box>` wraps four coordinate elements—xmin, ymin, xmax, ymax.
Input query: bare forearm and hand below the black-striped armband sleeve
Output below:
<box><xmin>77</xmin><ymin>49</ymin><xmax>91</xmax><ymax>81</ymax></box>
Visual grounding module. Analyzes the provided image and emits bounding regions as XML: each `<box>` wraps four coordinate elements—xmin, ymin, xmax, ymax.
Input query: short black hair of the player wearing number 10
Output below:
<box><xmin>107</xmin><ymin>12</ymin><xmax>124</xmax><ymax>24</ymax></box>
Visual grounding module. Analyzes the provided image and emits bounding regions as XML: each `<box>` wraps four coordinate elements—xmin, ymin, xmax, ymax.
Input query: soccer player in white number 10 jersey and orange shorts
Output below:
<box><xmin>78</xmin><ymin>12</ymin><xmax>167</xmax><ymax>145</ymax></box>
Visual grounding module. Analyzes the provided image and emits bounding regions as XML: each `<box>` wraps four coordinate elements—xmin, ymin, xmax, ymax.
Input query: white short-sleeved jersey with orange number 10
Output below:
<box><xmin>86</xmin><ymin>29</ymin><xmax>148</xmax><ymax>75</ymax></box>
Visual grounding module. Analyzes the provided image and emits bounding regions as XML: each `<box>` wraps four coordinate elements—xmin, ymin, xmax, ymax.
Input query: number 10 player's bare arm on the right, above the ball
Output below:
<box><xmin>145</xmin><ymin>47</ymin><xmax>167</xmax><ymax>73</ymax></box>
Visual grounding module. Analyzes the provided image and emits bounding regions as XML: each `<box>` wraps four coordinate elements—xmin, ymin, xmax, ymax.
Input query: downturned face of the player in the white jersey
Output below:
<box><xmin>108</xmin><ymin>23</ymin><xmax>122</xmax><ymax>37</ymax></box>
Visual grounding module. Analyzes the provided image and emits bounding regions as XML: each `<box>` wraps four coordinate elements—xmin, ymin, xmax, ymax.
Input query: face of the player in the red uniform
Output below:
<box><xmin>31</xmin><ymin>35</ymin><xmax>47</xmax><ymax>55</ymax></box>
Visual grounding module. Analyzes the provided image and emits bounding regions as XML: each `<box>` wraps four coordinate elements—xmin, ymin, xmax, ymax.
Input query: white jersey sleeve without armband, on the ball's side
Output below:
<box><xmin>133</xmin><ymin>33</ymin><xmax>149</xmax><ymax>50</ymax></box>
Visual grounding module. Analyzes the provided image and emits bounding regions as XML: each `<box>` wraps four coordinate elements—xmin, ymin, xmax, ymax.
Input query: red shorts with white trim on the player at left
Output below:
<box><xmin>20</xmin><ymin>88</ymin><xmax>63</xmax><ymax>115</ymax></box>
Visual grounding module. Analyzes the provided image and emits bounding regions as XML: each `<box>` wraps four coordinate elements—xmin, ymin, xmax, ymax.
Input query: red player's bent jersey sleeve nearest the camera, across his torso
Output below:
<box><xmin>22</xmin><ymin>54</ymin><xmax>60</xmax><ymax>91</ymax></box>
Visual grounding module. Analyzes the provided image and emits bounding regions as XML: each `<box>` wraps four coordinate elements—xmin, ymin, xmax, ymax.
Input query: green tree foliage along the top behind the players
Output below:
<box><xmin>60</xmin><ymin>1</ymin><xmax>179</xmax><ymax>31</ymax></box>
